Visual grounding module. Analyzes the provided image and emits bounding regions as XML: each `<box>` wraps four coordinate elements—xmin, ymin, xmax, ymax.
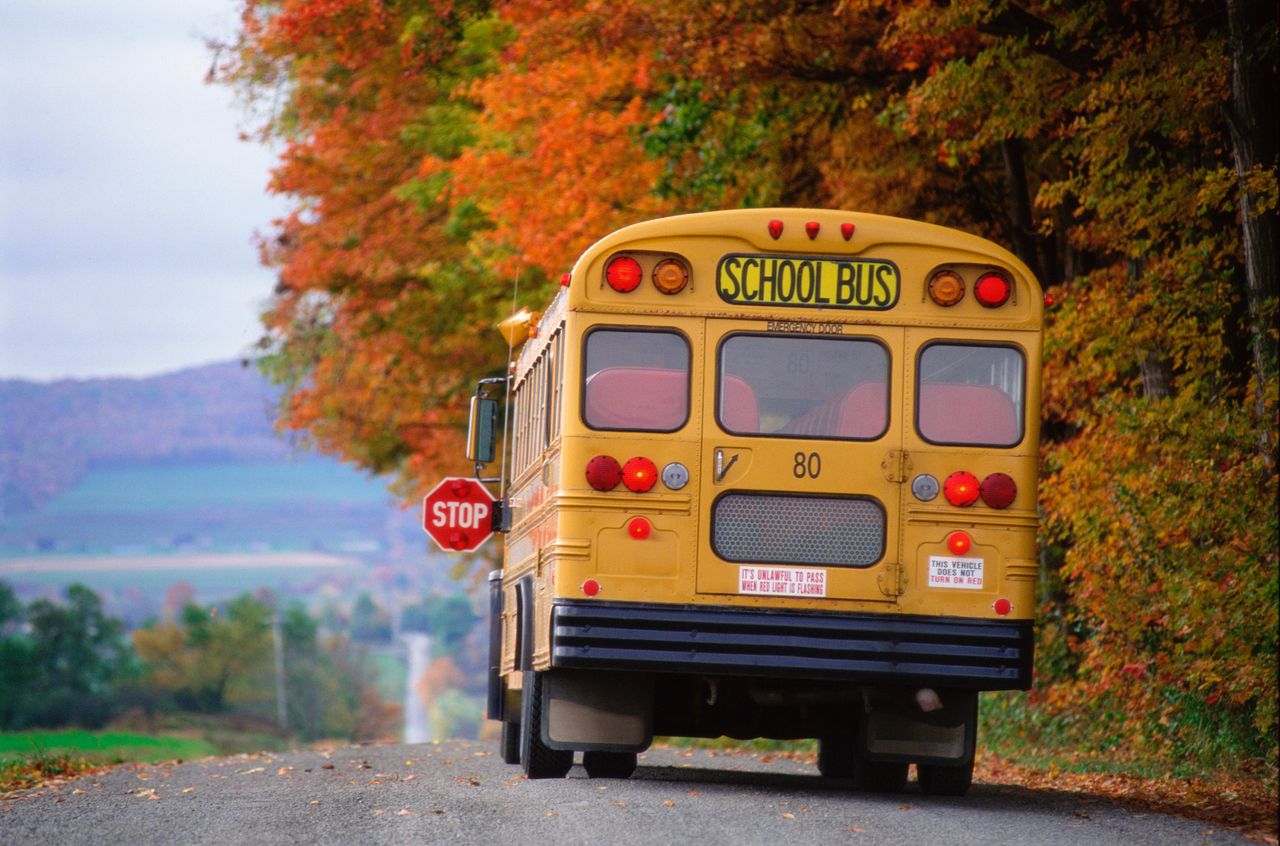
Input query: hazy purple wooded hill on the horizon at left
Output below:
<box><xmin>0</xmin><ymin>361</ymin><xmax>291</xmax><ymax>521</ymax></box>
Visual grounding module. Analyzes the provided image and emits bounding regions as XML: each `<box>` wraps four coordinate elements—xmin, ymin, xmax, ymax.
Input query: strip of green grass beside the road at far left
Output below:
<box><xmin>0</xmin><ymin>731</ymin><xmax>218</xmax><ymax>792</ymax></box>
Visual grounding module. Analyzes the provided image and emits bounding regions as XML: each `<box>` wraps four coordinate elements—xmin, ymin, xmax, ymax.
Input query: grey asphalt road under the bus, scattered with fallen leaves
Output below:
<box><xmin>0</xmin><ymin>741</ymin><xmax>1249</xmax><ymax>846</ymax></box>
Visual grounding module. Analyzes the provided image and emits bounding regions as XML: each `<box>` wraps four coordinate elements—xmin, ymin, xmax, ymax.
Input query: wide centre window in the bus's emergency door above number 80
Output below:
<box><xmin>716</xmin><ymin>334</ymin><xmax>888</xmax><ymax>440</ymax></box>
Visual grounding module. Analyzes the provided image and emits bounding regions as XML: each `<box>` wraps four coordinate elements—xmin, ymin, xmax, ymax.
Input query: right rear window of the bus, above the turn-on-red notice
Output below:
<box><xmin>915</xmin><ymin>343</ymin><xmax>1027</xmax><ymax>447</ymax></box>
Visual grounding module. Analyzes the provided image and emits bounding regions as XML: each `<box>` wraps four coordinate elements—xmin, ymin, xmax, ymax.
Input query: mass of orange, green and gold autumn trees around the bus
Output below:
<box><xmin>220</xmin><ymin>0</ymin><xmax>1280</xmax><ymax>763</ymax></box>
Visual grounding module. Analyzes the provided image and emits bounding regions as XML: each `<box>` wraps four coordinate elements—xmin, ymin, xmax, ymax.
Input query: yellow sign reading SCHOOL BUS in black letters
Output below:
<box><xmin>716</xmin><ymin>253</ymin><xmax>901</xmax><ymax>311</ymax></box>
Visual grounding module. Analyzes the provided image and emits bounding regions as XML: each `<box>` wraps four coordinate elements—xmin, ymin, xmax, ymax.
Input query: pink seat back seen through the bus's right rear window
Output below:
<box><xmin>916</xmin><ymin>383</ymin><xmax>1019</xmax><ymax>447</ymax></box>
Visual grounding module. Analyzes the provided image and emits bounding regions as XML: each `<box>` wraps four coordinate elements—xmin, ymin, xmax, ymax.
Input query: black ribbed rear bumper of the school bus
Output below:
<box><xmin>552</xmin><ymin>600</ymin><xmax>1033</xmax><ymax>690</ymax></box>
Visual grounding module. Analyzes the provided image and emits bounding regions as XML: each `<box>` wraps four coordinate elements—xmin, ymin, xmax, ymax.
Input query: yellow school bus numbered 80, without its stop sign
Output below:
<box><xmin>470</xmin><ymin>209</ymin><xmax>1043</xmax><ymax>795</ymax></box>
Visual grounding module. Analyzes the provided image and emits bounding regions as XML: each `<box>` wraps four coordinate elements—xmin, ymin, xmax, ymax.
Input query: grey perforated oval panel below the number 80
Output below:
<box><xmin>712</xmin><ymin>493</ymin><xmax>884</xmax><ymax>567</ymax></box>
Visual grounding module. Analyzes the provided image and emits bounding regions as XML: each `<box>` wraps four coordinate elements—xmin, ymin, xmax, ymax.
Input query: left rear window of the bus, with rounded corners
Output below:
<box><xmin>582</xmin><ymin>329</ymin><xmax>690</xmax><ymax>431</ymax></box>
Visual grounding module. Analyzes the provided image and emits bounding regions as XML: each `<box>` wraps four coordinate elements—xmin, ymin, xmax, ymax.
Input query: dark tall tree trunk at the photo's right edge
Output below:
<box><xmin>1225</xmin><ymin>0</ymin><xmax>1280</xmax><ymax>432</ymax></box>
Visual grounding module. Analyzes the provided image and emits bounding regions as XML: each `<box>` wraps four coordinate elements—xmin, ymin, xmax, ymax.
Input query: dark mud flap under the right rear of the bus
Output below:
<box><xmin>858</xmin><ymin>690</ymin><xmax>978</xmax><ymax>764</ymax></box>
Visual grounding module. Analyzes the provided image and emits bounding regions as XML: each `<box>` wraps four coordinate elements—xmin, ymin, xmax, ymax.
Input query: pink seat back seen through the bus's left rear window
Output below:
<box><xmin>584</xmin><ymin>367</ymin><xmax>689</xmax><ymax>431</ymax></box>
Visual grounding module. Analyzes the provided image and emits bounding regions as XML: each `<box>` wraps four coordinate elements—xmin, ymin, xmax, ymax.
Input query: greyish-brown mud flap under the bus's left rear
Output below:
<box><xmin>543</xmin><ymin>669</ymin><xmax>653</xmax><ymax>753</ymax></box>
